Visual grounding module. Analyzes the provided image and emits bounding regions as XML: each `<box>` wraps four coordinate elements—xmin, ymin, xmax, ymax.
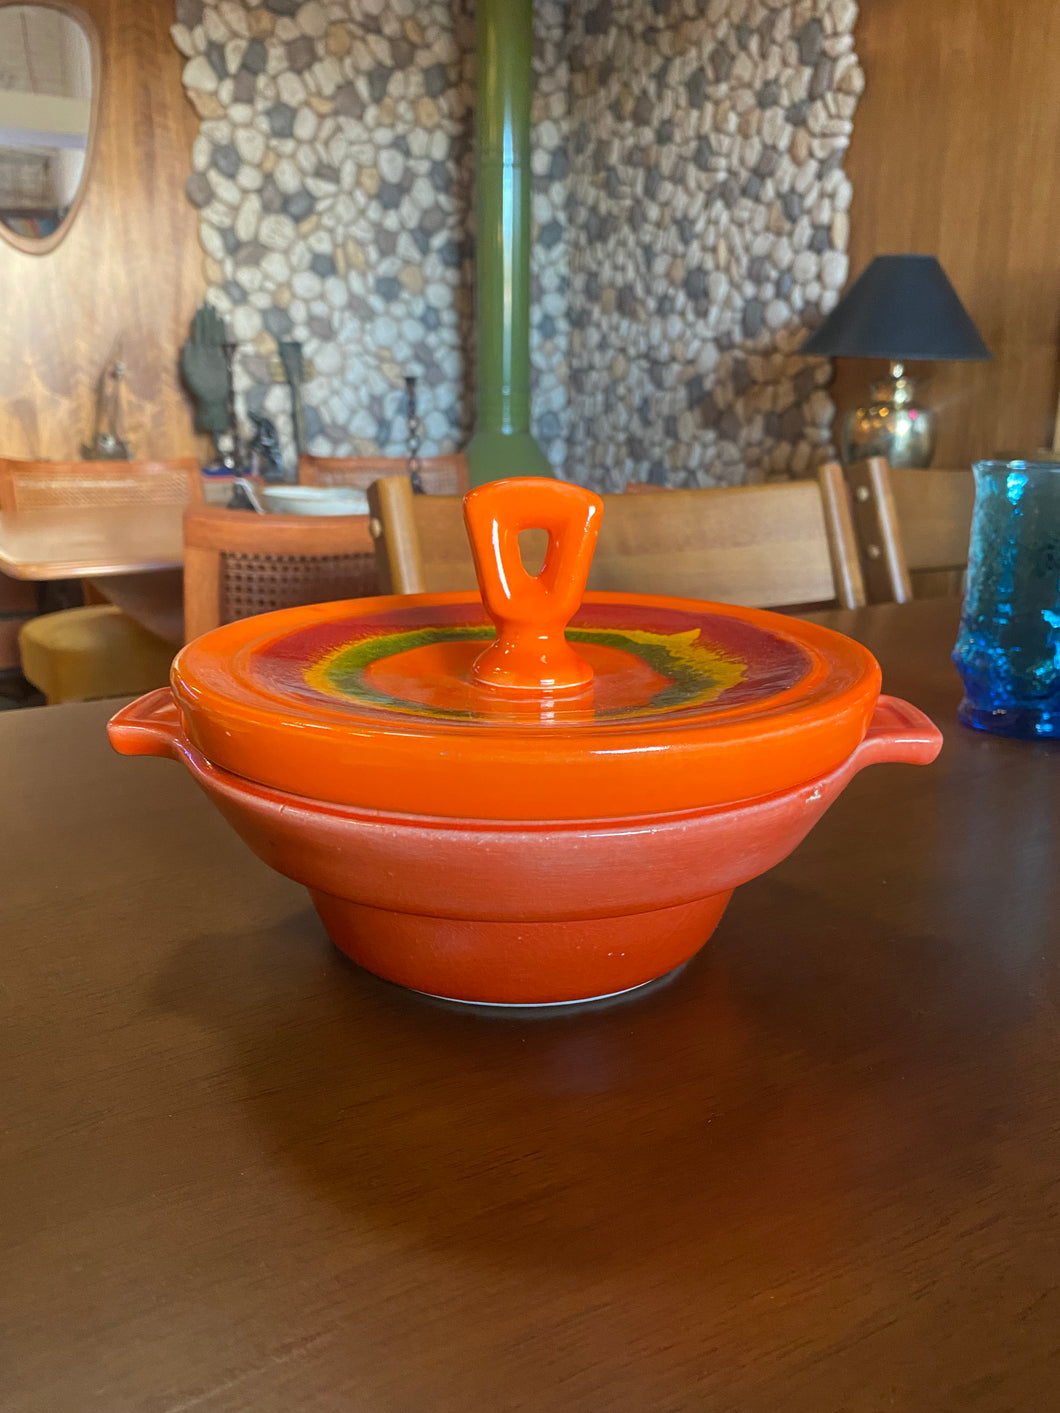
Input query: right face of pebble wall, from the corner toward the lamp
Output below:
<box><xmin>568</xmin><ymin>0</ymin><xmax>864</xmax><ymax>489</ymax></box>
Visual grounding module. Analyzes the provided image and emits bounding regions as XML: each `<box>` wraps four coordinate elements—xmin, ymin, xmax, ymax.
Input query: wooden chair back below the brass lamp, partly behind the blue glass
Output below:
<box><xmin>847</xmin><ymin>456</ymin><xmax>975</xmax><ymax>603</ymax></box>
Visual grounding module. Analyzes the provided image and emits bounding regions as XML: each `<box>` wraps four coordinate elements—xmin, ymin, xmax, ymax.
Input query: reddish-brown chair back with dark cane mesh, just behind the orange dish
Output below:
<box><xmin>184</xmin><ymin>508</ymin><xmax>378</xmax><ymax>642</ymax></box>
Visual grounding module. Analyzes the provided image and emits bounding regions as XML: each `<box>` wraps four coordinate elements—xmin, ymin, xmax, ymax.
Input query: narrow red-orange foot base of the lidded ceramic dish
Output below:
<box><xmin>311</xmin><ymin>892</ymin><xmax>731</xmax><ymax>1006</ymax></box>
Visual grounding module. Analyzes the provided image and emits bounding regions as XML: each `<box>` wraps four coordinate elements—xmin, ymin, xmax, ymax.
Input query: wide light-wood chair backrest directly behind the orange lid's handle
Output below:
<box><xmin>369</xmin><ymin>463</ymin><xmax>865</xmax><ymax>608</ymax></box>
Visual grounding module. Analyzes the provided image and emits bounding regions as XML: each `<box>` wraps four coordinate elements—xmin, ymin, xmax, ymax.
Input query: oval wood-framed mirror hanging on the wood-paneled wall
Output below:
<box><xmin>0</xmin><ymin>0</ymin><xmax>99</xmax><ymax>254</ymax></box>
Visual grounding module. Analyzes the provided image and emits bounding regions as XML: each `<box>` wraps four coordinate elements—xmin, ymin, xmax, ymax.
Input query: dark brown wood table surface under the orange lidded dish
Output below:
<box><xmin>0</xmin><ymin>602</ymin><xmax>1060</xmax><ymax>1413</ymax></box>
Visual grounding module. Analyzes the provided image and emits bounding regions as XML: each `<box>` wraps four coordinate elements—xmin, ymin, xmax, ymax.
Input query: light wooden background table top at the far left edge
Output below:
<box><xmin>0</xmin><ymin>504</ymin><xmax>184</xmax><ymax>579</ymax></box>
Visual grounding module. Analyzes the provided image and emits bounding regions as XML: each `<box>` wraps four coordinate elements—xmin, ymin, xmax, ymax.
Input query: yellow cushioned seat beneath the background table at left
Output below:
<box><xmin>18</xmin><ymin>603</ymin><xmax>177</xmax><ymax>702</ymax></box>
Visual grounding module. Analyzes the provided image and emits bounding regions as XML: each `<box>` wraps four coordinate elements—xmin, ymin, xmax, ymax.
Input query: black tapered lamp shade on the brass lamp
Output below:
<box><xmin>800</xmin><ymin>256</ymin><xmax>991</xmax><ymax>362</ymax></box>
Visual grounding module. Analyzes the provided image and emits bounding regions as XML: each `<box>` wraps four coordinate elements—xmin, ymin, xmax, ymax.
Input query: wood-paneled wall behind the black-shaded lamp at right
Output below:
<box><xmin>834</xmin><ymin>0</ymin><xmax>1060</xmax><ymax>466</ymax></box>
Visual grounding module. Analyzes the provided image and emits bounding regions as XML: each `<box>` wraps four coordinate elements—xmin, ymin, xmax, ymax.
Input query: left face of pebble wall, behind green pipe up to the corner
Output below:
<box><xmin>172</xmin><ymin>0</ymin><xmax>568</xmax><ymax>468</ymax></box>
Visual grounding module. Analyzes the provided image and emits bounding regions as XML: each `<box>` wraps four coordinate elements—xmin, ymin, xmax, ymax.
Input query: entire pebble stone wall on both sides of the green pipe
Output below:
<box><xmin>172</xmin><ymin>0</ymin><xmax>864</xmax><ymax>489</ymax></box>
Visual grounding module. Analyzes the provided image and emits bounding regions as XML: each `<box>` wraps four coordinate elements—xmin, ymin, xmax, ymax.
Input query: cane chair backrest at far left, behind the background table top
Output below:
<box><xmin>0</xmin><ymin>456</ymin><xmax>202</xmax><ymax>512</ymax></box>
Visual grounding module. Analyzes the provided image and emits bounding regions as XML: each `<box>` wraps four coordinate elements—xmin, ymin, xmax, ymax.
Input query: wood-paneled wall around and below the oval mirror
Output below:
<box><xmin>0</xmin><ymin>0</ymin><xmax>205</xmax><ymax>458</ymax></box>
